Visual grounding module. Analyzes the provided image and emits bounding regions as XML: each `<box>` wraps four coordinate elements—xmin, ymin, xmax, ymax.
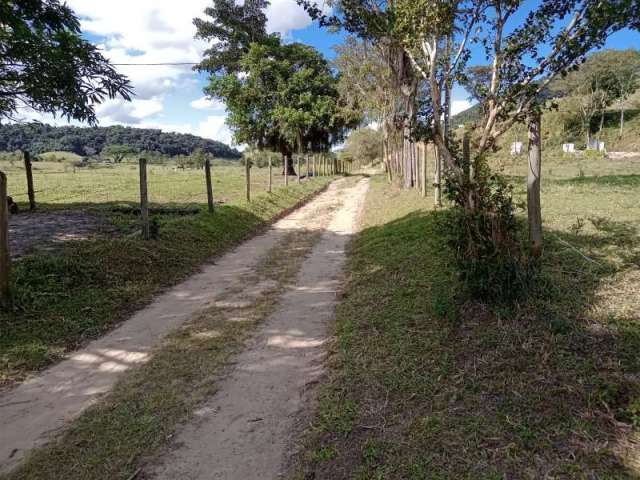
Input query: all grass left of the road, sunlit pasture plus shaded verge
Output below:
<box><xmin>0</xmin><ymin>158</ymin><xmax>332</xmax><ymax>388</ymax></box>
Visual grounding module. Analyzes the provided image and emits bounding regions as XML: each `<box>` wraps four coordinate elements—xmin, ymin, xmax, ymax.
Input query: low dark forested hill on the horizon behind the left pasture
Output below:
<box><xmin>0</xmin><ymin>123</ymin><xmax>240</xmax><ymax>158</ymax></box>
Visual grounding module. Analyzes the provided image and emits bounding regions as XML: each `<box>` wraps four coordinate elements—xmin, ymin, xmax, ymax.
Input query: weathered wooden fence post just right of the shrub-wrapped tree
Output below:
<box><xmin>527</xmin><ymin>114</ymin><xmax>542</xmax><ymax>258</ymax></box>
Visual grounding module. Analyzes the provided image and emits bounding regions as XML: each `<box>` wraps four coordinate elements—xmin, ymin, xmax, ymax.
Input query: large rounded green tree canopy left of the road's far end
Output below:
<box><xmin>196</xmin><ymin>0</ymin><xmax>360</xmax><ymax>164</ymax></box>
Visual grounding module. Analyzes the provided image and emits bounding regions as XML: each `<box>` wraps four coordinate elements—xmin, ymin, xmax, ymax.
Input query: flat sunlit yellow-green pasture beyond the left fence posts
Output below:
<box><xmin>0</xmin><ymin>161</ymin><xmax>290</xmax><ymax>209</ymax></box>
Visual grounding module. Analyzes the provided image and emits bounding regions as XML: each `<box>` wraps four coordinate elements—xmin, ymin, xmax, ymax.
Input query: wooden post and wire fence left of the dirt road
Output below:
<box><xmin>0</xmin><ymin>152</ymin><xmax>349</xmax><ymax>308</ymax></box>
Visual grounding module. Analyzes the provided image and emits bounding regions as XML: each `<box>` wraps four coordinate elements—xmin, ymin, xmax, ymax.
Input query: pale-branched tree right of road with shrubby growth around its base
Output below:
<box><xmin>298</xmin><ymin>0</ymin><xmax>640</xmax><ymax>283</ymax></box>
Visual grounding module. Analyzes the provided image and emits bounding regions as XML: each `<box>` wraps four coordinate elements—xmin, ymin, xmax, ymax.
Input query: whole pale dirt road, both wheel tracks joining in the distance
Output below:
<box><xmin>0</xmin><ymin>180</ymin><xmax>368</xmax><ymax>479</ymax></box>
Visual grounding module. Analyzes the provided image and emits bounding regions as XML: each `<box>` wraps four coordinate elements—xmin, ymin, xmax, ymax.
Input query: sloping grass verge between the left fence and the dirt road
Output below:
<box><xmin>0</xmin><ymin>178</ymin><xmax>329</xmax><ymax>386</ymax></box>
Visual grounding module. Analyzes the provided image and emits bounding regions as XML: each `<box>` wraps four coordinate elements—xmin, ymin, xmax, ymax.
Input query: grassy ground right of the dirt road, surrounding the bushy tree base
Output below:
<box><xmin>293</xmin><ymin>174</ymin><xmax>640</xmax><ymax>480</ymax></box>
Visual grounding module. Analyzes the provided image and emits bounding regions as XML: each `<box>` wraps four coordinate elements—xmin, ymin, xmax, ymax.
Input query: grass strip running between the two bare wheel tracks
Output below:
<box><xmin>2</xmin><ymin>224</ymin><xmax>321</xmax><ymax>480</ymax></box>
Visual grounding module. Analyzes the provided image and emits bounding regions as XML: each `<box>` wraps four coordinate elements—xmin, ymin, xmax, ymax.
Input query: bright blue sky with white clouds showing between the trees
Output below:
<box><xmin>23</xmin><ymin>0</ymin><xmax>640</xmax><ymax>143</ymax></box>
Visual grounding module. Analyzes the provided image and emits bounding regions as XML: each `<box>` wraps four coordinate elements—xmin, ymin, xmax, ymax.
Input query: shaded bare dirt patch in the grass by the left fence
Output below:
<box><xmin>9</xmin><ymin>210</ymin><xmax>108</xmax><ymax>258</ymax></box>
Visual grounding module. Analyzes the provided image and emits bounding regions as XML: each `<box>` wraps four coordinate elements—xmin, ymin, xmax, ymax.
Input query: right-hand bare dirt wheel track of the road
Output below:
<box><xmin>146</xmin><ymin>180</ymin><xmax>368</xmax><ymax>480</ymax></box>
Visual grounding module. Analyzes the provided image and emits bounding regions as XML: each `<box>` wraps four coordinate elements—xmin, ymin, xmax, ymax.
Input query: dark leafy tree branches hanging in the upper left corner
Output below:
<box><xmin>0</xmin><ymin>0</ymin><xmax>132</xmax><ymax>124</ymax></box>
